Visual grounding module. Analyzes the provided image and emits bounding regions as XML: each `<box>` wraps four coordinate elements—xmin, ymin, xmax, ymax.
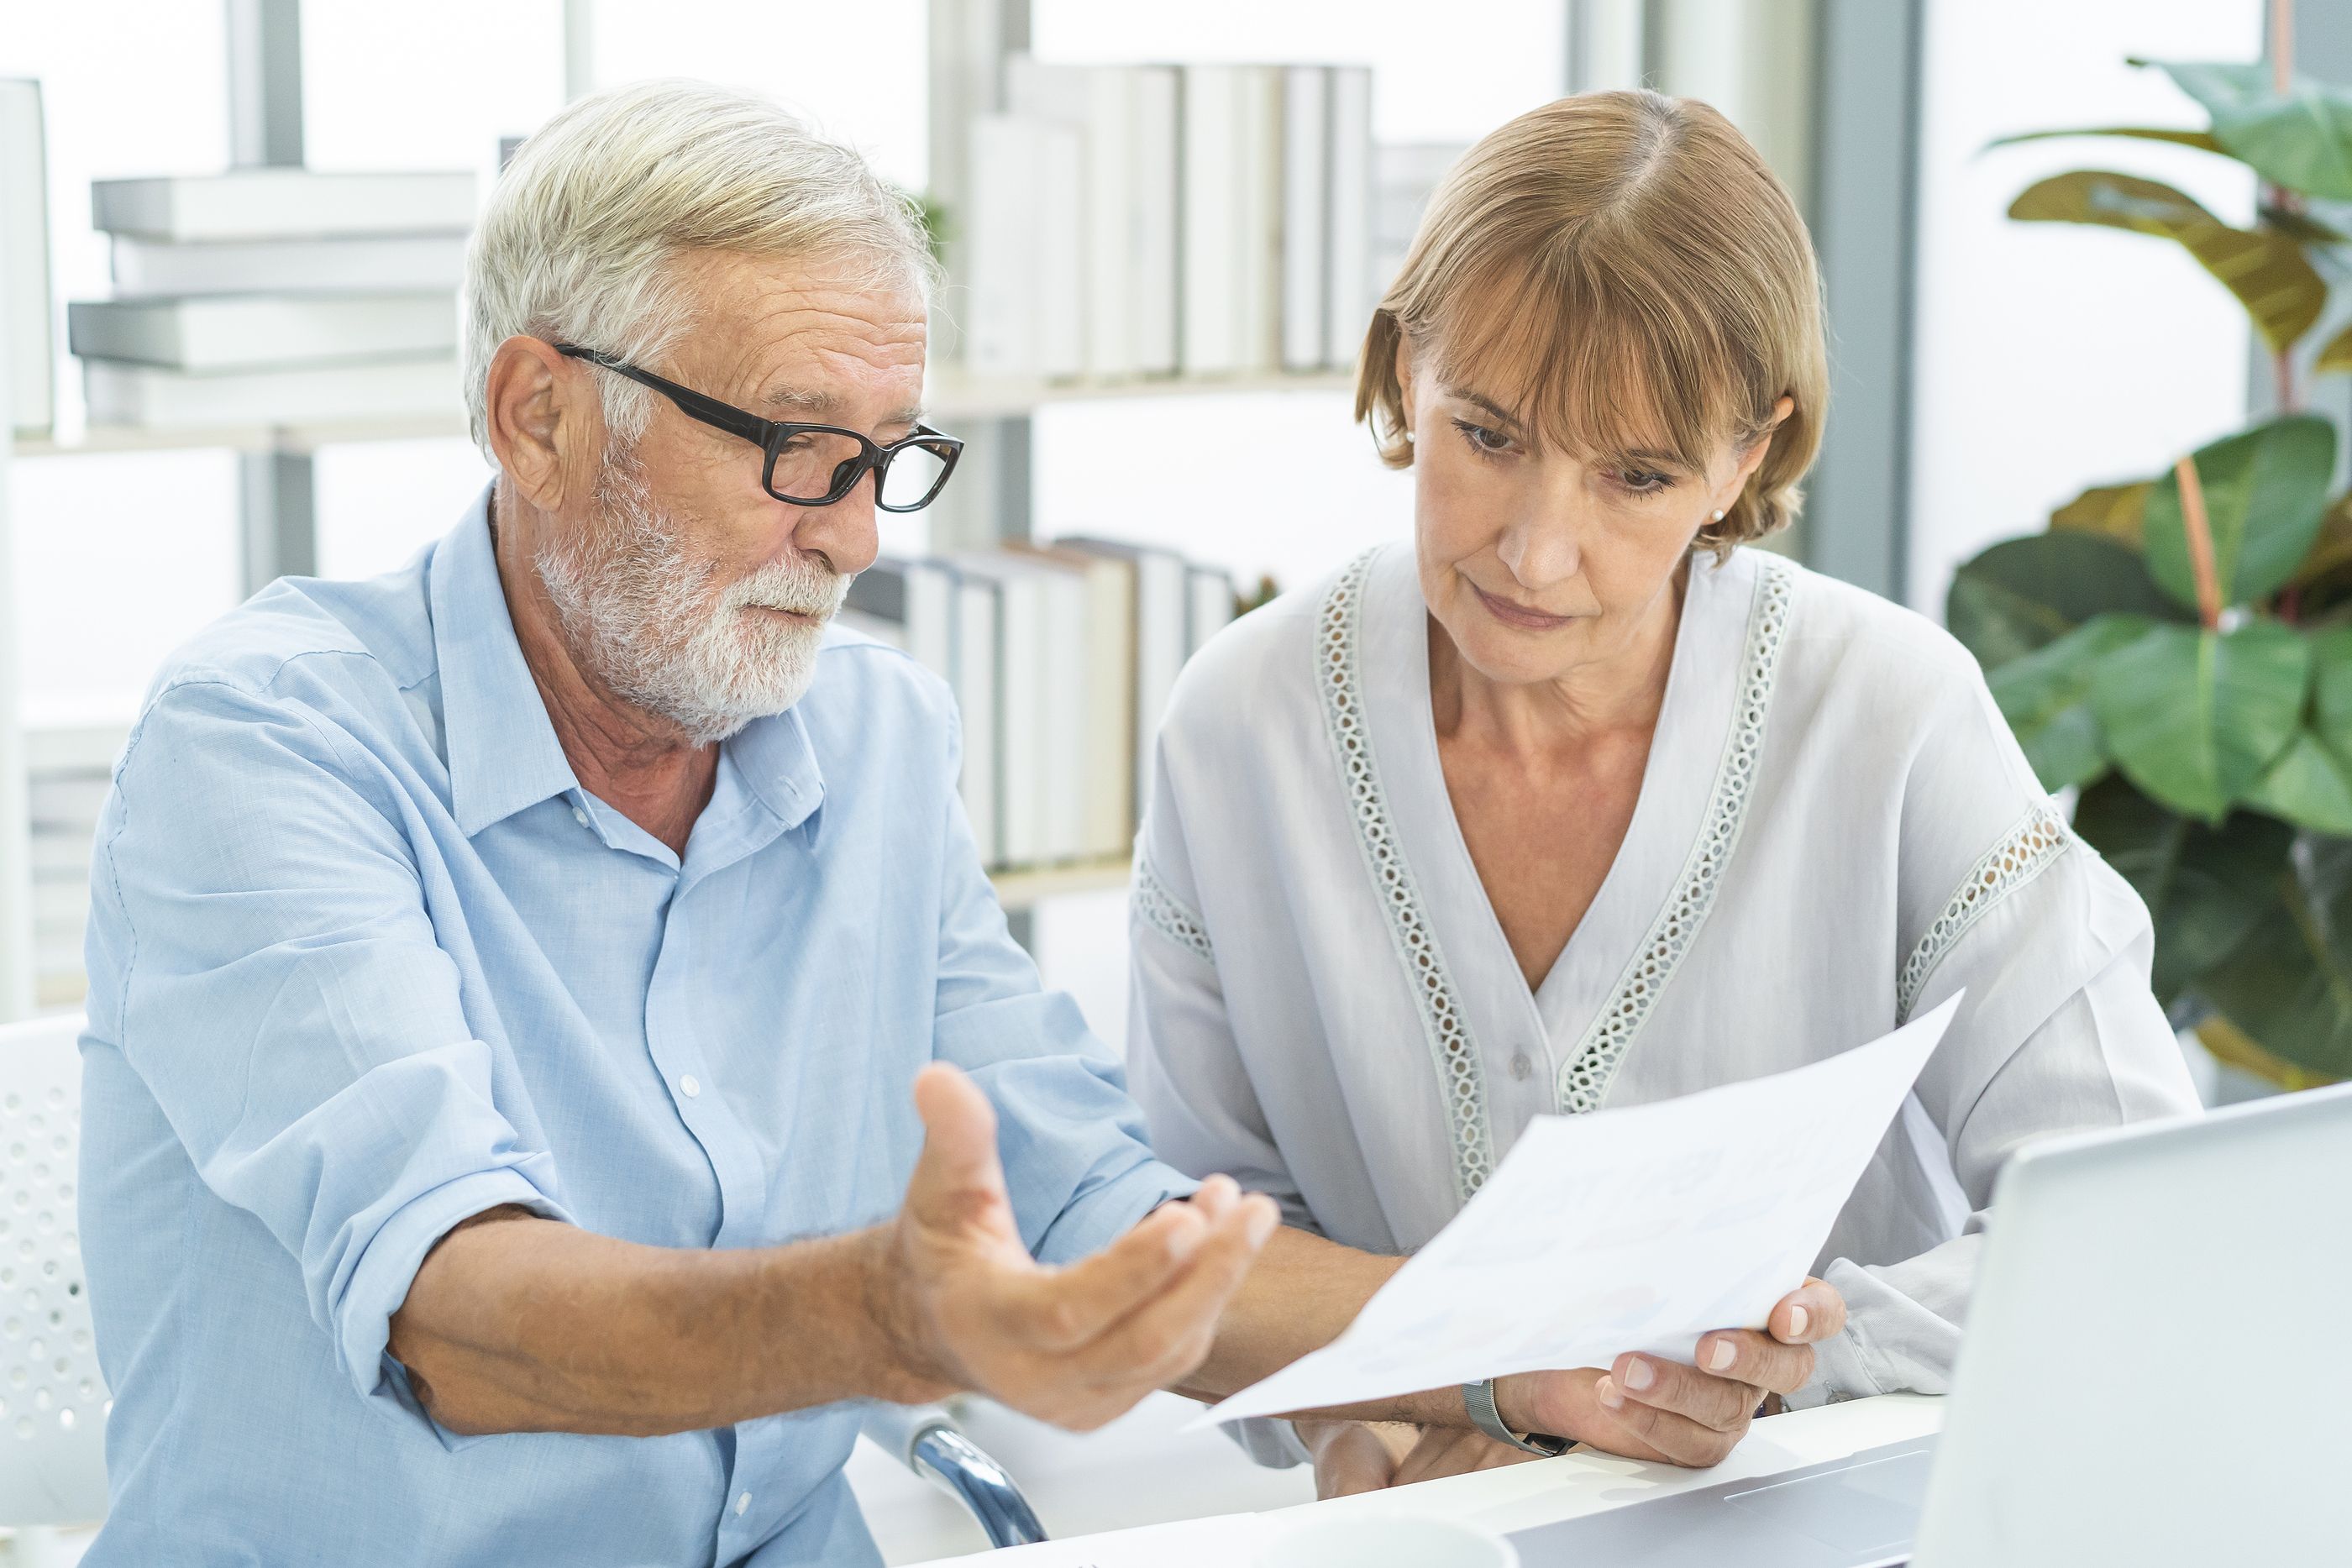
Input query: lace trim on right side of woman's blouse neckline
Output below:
<box><xmin>1555</xmin><ymin>553</ymin><xmax>1797</xmax><ymax>1114</ymax></box>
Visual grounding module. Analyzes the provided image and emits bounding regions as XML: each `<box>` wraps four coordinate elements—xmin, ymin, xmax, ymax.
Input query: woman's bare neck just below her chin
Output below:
<box><xmin>1428</xmin><ymin>562</ymin><xmax>1691</xmax><ymax>757</ymax></box>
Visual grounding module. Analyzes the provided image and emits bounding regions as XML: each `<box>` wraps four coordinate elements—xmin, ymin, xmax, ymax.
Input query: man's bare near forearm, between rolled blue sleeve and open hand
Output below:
<box><xmin>391</xmin><ymin>1211</ymin><xmax>943</xmax><ymax>1436</ymax></box>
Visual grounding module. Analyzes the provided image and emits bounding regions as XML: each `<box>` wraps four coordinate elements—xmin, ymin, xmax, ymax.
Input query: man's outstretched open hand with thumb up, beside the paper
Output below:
<box><xmin>868</xmin><ymin>1062</ymin><xmax>1282</xmax><ymax>1429</ymax></box>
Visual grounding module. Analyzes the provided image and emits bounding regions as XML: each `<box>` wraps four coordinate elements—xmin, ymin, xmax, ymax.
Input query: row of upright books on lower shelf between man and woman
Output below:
<box><xmin>842</xmin><ymin>538</ymin><xmax>1235</xmax><ymax>870</ymax></box>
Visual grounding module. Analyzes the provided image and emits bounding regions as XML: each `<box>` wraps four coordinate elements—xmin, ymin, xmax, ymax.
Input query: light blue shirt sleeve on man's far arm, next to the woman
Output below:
<box><xmin>934</xmin><ymin>719</ymin><xmax>1197</xmax><ymax>1262</ymax></box>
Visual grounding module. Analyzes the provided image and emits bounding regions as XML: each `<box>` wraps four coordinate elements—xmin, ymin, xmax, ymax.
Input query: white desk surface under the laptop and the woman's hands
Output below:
<box><xmin>907</xmin><ymin>1394</ymin><xmax>1943</xmax><ymax>1568</ymax></box>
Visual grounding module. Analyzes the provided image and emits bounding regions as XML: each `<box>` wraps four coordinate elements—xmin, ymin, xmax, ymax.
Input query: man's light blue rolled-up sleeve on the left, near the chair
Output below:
<box><xmin>89</xmin><ymin>679</ymin><xmax>570</xmax><ymax>1410</ymax></box>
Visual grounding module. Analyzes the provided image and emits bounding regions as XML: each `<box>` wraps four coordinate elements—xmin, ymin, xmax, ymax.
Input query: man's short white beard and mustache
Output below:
<box><xmin>532</xmin><ymin>459</ymin><xmax>849</xmax><ymax>745</ymax></box>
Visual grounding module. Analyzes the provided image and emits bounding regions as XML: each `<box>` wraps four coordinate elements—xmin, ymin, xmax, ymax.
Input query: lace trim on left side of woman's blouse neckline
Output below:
<box><xmin>1315</xmin><ymin>550</ymin><xmax>1494</xmax><ymax>1201</ymax></box>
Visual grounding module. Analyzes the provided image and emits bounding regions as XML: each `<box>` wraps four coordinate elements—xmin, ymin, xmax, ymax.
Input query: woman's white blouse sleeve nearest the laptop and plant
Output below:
<box><xmin>1790</xmin><ymin>673</ymin><xmax>2197</xmax><ymax>1408</ymax></box>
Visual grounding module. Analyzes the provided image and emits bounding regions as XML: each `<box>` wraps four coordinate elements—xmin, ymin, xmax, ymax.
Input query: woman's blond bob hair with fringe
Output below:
<box><xmin>1355</xmin><ymin>92</ymin><xmax>1830</xmax><ymax>553</ymax></box>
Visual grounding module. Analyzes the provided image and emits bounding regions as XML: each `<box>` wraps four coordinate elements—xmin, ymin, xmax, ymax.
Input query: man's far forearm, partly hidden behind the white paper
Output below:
<box><xmin>1176</xmin><ymin>1227</ymin><xmax>1470</xmax><ymax>1427</ymax></box>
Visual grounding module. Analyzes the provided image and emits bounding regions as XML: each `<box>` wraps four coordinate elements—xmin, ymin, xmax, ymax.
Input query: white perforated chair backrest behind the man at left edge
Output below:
<box><xmin>0</xmin><ymin>1015</ymin><xmax>113</xmax><ymax>1526</ymax></box>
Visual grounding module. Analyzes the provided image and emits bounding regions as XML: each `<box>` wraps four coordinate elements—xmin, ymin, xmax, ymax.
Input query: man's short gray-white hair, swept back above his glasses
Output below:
<box><xmin>461</xmin><ymin>80</ymin><xmax>938</xmax><ymax>463</ymax></box>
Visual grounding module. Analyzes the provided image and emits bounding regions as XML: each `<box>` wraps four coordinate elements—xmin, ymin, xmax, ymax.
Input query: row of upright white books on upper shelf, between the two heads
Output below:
<box><xmin>964</xmin><ymin>56</ymin><xmax>1373</xmax><ymax>380</ymax></box>
